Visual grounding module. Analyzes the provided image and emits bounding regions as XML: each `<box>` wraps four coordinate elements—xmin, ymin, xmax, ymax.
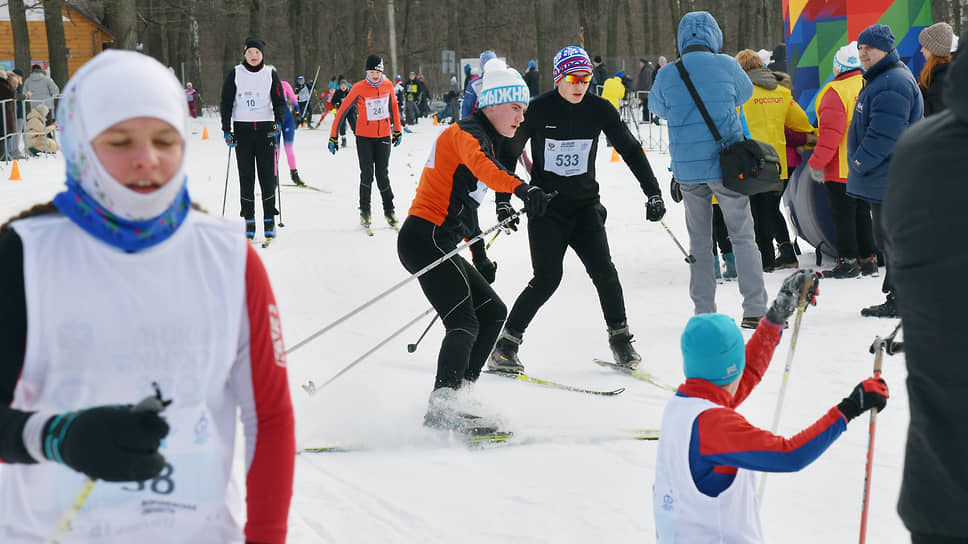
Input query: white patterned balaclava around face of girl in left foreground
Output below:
<box><xmin>57</xmin><ymin>49</ymin><xmax>188</xmax><ymax>221</ymax></box>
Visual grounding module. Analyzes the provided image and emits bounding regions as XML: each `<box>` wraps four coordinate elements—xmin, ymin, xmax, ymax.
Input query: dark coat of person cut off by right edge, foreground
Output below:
<box><xmin>884</xmin><ymin>43</ymin><xmax>968</xmax><ymax>539</ymax></box>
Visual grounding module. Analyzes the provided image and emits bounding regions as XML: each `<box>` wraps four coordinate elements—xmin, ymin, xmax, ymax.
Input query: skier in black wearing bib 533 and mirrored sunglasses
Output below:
<box><xmin>488</xmin><ymin>46</ymin><xmax>665</xmax><ymax>372</ymax></box>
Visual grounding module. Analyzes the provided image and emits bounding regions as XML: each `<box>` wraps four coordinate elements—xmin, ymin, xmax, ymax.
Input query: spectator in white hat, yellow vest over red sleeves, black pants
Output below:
<box><xmin>808</xmin><ymin>42</ymin><xmax>877</xmax><ymax>278</ymax></box>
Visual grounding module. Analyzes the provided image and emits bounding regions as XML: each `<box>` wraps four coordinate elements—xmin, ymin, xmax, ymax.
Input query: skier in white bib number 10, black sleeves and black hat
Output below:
<box><xmin>222</xmin><ymin>36</ymin><xmax>286</xmax><ymax>240</ymax></box>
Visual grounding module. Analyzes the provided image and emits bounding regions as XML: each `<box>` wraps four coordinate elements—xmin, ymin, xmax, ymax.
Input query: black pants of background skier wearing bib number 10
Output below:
<box><xmin>232</xmin><ymin>121</ymin><xmax>279</xmax><ymax>219</ymax></box>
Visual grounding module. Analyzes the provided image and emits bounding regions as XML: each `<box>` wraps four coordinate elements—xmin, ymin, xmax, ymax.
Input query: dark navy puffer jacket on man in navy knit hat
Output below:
<box><xmin>847</xmin><ymin>49</ymin><xmax>924</xmax><ymax>202</ymax></box>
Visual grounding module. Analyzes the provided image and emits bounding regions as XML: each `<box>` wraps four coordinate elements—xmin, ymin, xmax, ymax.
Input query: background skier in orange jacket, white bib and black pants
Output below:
<box><xmin>329</xmin><ymin>55</ymin><xmax>402</xmax><ymax>232</ymax></box>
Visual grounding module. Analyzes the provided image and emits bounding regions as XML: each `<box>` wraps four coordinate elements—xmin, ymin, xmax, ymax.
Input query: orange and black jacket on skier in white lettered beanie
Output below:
<box><xmin>410</xmin><ymin>111</ymin><xmax>523</xmax><ymax>238</ymax></box>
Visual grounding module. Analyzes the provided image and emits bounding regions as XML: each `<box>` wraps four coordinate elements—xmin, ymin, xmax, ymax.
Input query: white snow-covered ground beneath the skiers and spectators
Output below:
<box><xmin>0</xmin><ymin>112</ymin><xmax>909</xmax><ymax>544</ymax></box>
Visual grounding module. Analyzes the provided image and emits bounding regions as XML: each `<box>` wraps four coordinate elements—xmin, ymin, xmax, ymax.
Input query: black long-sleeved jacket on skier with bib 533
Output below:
<box><xmin>498</xmin><ymin>89</ymin><xmax>661</xmax><ymax>211</ymax></box>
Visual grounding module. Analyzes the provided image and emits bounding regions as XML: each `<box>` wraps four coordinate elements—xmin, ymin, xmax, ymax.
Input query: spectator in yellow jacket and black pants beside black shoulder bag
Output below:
<box><xmin>736</xmin><ymin>49</ymin><xmax>813</xmax><ymax>272</ymax></box>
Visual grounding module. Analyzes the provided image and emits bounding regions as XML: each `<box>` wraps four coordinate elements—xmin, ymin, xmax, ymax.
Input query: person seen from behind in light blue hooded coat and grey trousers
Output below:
<box><xmin>649</xmin><ymin>11</ymin><xmax>767</xmax><ymax>329</ymax></box>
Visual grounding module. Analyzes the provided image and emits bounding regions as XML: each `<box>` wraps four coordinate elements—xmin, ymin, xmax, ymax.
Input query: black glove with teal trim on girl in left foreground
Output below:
<box><xmin>41</xmin><ymin>399</ymin><xmax>168</xmax><ymax>482</ymax></box>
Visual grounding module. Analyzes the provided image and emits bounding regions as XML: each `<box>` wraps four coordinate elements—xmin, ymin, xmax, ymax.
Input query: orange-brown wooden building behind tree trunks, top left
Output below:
<box><xmin>0</xmin><ymin>2</ymin><xmax>114</xmax><ymax>76</ymax></box>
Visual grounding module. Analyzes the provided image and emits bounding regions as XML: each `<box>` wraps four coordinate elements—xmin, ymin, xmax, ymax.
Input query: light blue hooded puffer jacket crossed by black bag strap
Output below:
<box><xmin>649</xmin><ymin>11</ymin><xmax>753</xmax><ymax>184</ymax></box>
